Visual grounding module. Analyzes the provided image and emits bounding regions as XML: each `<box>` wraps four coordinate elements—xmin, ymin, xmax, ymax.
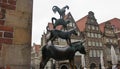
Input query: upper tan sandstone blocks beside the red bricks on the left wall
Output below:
<box><xmin>5</xmin><ymin>0</ymin><xmax>32</xmax><ymax>44</ymax></box>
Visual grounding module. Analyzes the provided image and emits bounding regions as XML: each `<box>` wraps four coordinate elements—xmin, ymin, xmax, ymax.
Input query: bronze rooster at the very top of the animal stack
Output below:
<box><xmin>52</xmin><ymin>5</ymin><xmax>69</xmax><ymax>18</ymax></box>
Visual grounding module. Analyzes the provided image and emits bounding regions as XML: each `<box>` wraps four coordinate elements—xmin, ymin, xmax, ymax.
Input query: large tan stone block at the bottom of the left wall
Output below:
<box><xmin>3</xmin><ymin>44</ymin><xmax>31</xmax><ymax>69</ymax></box>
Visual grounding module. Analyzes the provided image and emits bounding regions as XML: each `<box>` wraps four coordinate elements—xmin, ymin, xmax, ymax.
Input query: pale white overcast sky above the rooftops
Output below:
<box><xmin>32</xmin><ymin>0</ymin><xmax>120</xmax><ymax>44</ymax></box>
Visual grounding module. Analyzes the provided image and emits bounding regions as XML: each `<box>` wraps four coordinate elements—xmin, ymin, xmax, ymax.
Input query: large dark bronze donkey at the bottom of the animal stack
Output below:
<box><xmin>39</xmin><ymin>41</ymin><xmax>86</xmax><ymax>69</ymax></box>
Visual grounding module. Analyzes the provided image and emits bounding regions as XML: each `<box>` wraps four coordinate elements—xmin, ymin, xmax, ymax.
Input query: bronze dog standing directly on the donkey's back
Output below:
<box><xmin>47</xmin><ymin>29</ymin><xmax>77</xmax><ymax>45</ymax></box>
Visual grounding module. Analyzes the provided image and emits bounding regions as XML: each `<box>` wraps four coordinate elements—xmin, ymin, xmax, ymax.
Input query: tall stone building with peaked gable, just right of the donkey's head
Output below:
<box><xmin>76</xmin><ymin>11</ymin><xmax>104</xmax><ymax>69</ymax></box>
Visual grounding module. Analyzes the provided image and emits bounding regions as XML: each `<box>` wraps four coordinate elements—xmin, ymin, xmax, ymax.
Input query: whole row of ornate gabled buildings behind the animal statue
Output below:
<box><xmin>41</xmin><ymin>11</ymin><xmax>120</xmax><ymax>69</ymax></box>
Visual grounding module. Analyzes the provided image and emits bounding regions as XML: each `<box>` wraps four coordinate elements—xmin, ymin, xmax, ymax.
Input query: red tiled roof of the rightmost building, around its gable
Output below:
<box><xmin>99</xmin><ymin>18</ymin><xmax>120</xmax><ymax>32</ymax></box>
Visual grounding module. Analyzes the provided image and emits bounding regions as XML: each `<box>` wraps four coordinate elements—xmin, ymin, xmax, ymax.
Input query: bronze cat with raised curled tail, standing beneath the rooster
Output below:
<box><xmin>52</xmin><ymin>17</ymin><xmax>70</xmax><ymax>30</ymax></box>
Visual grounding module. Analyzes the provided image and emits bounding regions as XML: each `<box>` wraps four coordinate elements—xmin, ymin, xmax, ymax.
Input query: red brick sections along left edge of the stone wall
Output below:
<box><xmin>0</xmin><ymin>0</ymin><xmax>16</xmax><ymax>50</ymax></box>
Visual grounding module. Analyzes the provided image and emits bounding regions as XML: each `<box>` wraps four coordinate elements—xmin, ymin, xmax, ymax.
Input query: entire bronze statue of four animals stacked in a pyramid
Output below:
<box><xmin>39</xmin><ymin>6</ymin><xmax>86</xmax><ymax>69</ymax></box>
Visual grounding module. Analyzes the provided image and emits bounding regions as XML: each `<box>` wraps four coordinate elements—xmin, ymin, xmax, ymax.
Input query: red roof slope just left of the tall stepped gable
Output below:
<box><xmin>76</xmin><ymin>15</ymin><xmax>88</xmax><ymax>31</ymax></box>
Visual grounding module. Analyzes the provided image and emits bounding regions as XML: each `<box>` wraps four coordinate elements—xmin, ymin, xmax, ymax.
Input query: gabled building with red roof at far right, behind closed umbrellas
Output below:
<box><xmin>100</xmin><ymin>18</ymin><xmax>120</xmax><ymax>65</ymax></box>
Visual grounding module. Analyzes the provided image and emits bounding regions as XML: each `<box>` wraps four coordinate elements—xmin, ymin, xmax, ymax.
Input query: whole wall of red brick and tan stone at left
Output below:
<box><xmin>0</xmin><ymin>0</ymin><xmax>33</xmax><ymax>69</ymax></box>
